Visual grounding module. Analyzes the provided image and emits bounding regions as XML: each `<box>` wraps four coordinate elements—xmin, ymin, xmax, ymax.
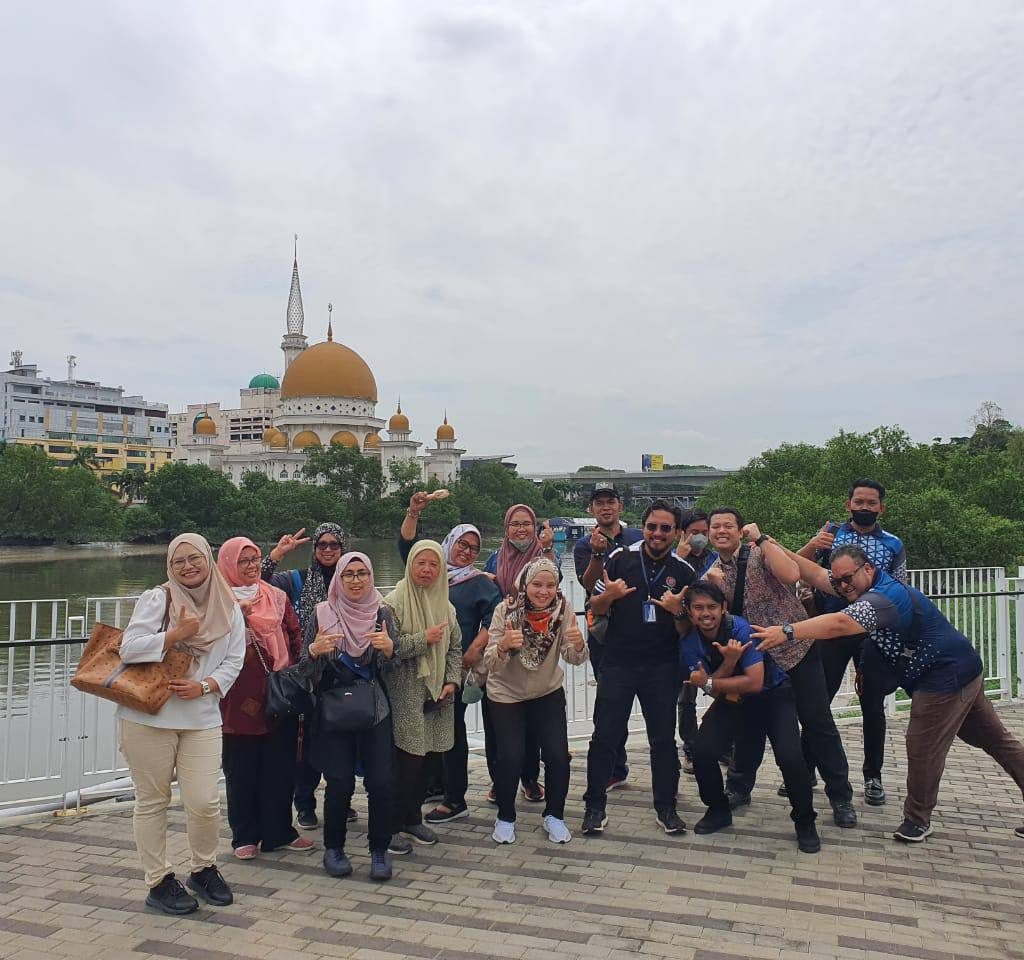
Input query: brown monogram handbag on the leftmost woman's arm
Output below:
<box><xmin>71</xmin><ymin>586</ymin><xmax>191</xmax><ymax>715</ymax></box>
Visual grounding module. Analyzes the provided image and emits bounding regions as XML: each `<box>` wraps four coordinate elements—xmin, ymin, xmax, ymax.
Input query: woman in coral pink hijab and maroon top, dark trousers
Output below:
<box><xmin>217</xmin><ymin>536</ymin><xmax>314</xmax><ymax>860</ymax></box>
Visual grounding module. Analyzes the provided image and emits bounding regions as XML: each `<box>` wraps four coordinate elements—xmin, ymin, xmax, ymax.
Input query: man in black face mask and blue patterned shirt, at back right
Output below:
<box><xmin>800</xmin><ymin>477</ymin><xmax>907</xmax><ymax>806</ymax></box>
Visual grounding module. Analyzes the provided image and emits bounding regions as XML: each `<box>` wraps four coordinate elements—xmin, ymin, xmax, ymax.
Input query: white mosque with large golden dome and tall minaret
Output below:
<box><xmin>168</xmin><ymin>243</ymin><xmax>466</xmax><ymax>484</ymax></box>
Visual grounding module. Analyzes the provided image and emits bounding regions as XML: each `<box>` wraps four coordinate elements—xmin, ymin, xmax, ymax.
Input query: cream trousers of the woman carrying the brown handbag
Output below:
<box><xmin>121</xmin><ymin>719</ymin><xmax>220</xmax><ymax>886</ymax></box>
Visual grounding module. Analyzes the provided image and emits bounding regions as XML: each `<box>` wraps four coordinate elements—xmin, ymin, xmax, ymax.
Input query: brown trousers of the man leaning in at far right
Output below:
<box><xmin>903</xmin><ymin>677</ymin><xmax>1024</xmax><ymax>827</ymax></box>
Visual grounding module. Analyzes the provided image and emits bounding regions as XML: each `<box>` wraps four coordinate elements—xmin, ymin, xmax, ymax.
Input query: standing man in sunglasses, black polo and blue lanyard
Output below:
<box><xmin>583</xmin><ymin>499</ymin><xmax>694</xmax><ymax>836</ymax></box>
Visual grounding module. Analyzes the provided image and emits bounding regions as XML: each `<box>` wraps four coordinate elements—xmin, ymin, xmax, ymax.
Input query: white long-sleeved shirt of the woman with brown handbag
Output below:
<box><xmin>117</xmin><ymin>586</ymin><xmax>246</xmax><ymax>730</ymax></box>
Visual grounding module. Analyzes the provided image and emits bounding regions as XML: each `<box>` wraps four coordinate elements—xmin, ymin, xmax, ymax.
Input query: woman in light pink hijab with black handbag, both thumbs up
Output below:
<box><xmin>305</xmin><ymin>552</ymin><xmax>397</xmax><ymax>880</ymax></box>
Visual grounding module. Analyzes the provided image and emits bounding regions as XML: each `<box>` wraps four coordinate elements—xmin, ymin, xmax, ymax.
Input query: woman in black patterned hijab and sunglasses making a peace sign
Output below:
<box><xmin>260</xmin><ymin>523</ymin><xmax>355</xmax><ymax>830</ymax></box>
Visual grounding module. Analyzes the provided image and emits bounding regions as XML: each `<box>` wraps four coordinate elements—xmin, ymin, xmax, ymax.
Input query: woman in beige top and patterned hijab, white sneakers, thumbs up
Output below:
<box><xmin>483</xmin><ymin>557</ymin><xmax>587</xmax><ymax>843</ymax></box>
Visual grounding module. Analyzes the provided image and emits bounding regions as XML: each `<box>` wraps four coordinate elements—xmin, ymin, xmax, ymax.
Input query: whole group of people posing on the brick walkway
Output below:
<box><xmin>118</xmin><ymin>480</ymin><xmax>1024</xmax><ymax>915</ymax></box>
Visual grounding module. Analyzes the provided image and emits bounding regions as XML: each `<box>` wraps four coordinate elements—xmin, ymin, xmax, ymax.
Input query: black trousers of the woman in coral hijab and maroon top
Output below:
<box><xmin>221</xmin><ymin>722</ymin><xmax>298</xmax><ymax>850</ymax></box>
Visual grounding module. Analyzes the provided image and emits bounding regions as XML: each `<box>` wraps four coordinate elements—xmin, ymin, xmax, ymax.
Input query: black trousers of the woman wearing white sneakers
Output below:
<box><xmin>489</xmin><ymin>687</ymin><xmax>569</xmax><ymax>823</ymax></box>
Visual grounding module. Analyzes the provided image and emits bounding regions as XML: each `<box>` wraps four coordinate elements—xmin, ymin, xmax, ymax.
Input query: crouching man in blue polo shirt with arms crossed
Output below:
<box><xmin>680</xmin><ymin>580</ymin><xmax>821</xmax><ymax>854</ymax></box>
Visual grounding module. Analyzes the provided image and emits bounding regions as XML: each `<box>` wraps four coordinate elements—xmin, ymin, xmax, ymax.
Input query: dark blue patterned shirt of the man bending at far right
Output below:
<box><xmin>843</xmin><ymin>571</ymin><xmax>982</xmax><ymax>694</ymax></box>
